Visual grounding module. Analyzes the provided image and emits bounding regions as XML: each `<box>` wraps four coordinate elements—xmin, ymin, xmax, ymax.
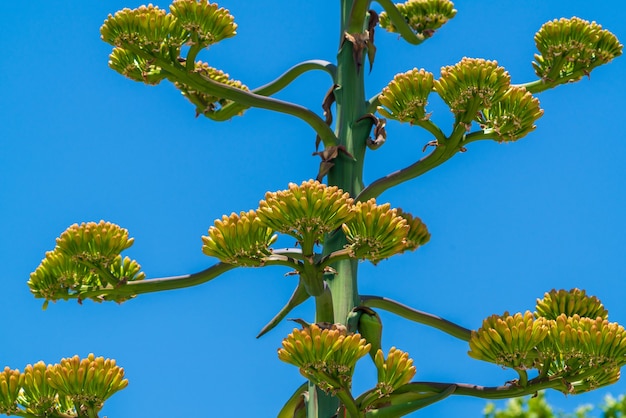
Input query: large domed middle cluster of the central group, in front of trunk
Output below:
<box><xmin>257</xmin><ymin>180</ymin><xmax>353</xmax><ymax>248</ymax></box>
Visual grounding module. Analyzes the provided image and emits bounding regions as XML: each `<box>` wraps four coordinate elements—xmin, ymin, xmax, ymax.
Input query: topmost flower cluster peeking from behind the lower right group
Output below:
<box><xmin>535</xmin><ymin>289</ymin><xmax>609</xmax><ymax>319</ymax></box>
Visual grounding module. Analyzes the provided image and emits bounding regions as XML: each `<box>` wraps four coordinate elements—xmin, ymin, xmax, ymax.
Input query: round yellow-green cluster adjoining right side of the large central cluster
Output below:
<box><xmin>342</xmin><ymin>199</ymin><xmax>410</xmax><ymax>264</ymax></box>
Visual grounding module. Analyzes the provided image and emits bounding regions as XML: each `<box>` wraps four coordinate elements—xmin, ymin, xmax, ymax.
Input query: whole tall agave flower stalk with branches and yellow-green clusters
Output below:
<box><xmin>22</xmin><ymin>0</ymin><xmax>626</xmax><ymax>418</ymax></box>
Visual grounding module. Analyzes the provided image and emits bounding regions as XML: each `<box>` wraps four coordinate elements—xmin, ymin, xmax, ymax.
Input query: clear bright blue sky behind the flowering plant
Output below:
<box><xmin>0</xmin><ymin>0</ymin><xmax>626</xmax><ymax>418</ymax></box>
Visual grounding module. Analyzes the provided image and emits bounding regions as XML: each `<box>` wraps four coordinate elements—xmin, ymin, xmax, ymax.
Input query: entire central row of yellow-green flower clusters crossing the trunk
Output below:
<box><xmin>202</xmin><ymin>180</ymin><xmax>430</xmax><ymax>266</ymax></box>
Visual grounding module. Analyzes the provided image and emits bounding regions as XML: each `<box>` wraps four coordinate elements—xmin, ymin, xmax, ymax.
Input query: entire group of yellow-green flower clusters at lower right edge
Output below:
<box><xmin>469</xmin><ymin>289</ymin><xmax>626</xmax><ymax>393</ymax></box>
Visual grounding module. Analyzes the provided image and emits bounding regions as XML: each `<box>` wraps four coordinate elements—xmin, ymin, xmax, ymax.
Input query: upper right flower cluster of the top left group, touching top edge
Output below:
<box><xmin>170</xmin><ymin>0</ymin><xmax>237</xmax><ymax>47</ymax></box>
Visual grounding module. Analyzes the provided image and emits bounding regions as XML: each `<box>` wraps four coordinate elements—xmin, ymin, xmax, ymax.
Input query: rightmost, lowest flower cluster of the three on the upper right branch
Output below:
<box><xmin>478</xmin><ymin>86</ymin><xmax>543</xmax><ymax>142</ymax></box>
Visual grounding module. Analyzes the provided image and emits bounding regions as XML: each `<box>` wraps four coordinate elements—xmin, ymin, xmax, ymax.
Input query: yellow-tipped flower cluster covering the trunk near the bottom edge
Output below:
<box><xmin>278</xmin><ymin>324</ymin><xmax>371</xmax><ymax>393</ymax></box>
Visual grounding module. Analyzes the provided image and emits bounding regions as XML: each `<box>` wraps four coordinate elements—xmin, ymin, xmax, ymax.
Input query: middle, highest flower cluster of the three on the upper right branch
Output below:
<box><xmin>434</xmin><ymin>58</ymin><xmax>511</xmax><ymax>123</ymax></box>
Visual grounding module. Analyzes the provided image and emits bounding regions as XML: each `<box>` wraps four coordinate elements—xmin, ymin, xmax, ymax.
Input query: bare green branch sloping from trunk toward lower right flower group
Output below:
<box><xmin>361</xmin><ymin>296</ymin><xmax>472</xmax><ymax>341</ymax></box>
